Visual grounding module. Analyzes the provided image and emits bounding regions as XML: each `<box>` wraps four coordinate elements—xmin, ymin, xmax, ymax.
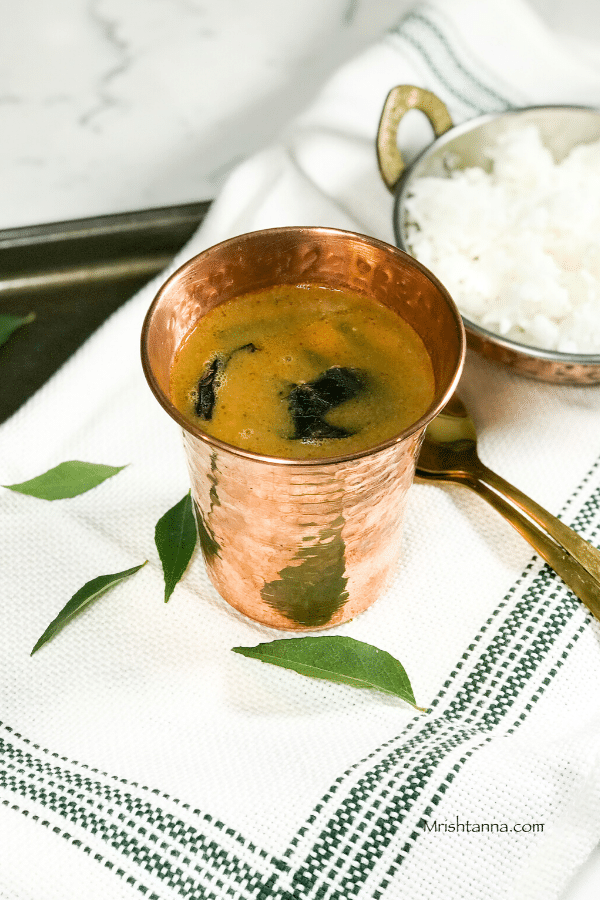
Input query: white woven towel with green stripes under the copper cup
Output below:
<box><xmin>0</xmin><ymin>0</ymin><xmax>600</xmax><ymax>900</ymax></box>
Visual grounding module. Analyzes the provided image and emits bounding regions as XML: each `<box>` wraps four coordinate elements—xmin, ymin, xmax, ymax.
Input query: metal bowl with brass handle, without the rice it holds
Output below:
<box><xmin>377</xmin><ymin>85</ymin><xmax>600</xmax><ymax>385</ymax></box>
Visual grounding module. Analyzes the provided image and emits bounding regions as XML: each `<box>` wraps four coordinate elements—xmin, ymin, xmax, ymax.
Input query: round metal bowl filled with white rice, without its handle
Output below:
<box><xmin>380</xmin><ymin>89</ymin><xmax>600</xmax><ymax>384</ymax></box>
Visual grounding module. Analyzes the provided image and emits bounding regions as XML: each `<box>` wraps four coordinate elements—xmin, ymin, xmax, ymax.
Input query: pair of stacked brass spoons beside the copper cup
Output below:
<box><xmin>416</xmin><ymin>395</ymin><xmax>600</xmax><ymax>619</ymax></box>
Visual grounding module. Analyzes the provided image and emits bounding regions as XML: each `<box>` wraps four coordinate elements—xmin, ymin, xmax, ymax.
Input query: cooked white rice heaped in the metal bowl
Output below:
<box><xmin>406</xmin><ymin>126</ymin><xmax>600</xmax><ymax>353</ymax></box>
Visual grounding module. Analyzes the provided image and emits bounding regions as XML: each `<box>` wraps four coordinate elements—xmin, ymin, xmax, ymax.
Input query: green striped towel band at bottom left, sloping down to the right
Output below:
<box><xmin>0</xmin><ymin>725</ymin><xmax>289</xmax><ymax>900</ymax></box>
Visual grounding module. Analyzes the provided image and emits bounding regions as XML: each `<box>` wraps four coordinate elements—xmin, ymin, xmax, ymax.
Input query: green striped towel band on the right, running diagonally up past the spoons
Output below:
<box><xmin>278</xmin><ymin>461</ymin><xmax>600</xmax><ymax>900</ymax></box>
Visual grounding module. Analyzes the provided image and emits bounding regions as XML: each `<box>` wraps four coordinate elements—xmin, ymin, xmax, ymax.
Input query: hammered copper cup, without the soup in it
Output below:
<box><xmin>142</xmin><ymin>227</ymin><xmax>465</xmax><ymax>631</ymax></box>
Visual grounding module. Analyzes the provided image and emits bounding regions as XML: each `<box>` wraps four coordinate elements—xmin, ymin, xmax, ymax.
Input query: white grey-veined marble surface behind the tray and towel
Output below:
<box><xmin>0</xmin><ymin>0</ymin><xmax>600</xmax><ymax>900</ymax></box>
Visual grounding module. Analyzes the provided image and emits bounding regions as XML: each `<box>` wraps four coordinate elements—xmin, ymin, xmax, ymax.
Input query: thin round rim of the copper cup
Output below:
<box><xmin>141</xmin><ymin>225</ymin><xmax>466</xmax><ymax>468</ymax></box>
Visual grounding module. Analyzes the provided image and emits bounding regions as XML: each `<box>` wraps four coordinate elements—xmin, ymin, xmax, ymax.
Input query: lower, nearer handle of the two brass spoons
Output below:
<box><xmin>468</xmin><ymin>479</ymin><xmax>600</xmax><ymax>620</ymax></box>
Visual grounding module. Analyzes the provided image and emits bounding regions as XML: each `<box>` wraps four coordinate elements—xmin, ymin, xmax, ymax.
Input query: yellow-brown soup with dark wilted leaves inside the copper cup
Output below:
<box><xmin>171</xmin><ymin>285</ymin><xmax>434</xmax><ymax>459</ymax></box>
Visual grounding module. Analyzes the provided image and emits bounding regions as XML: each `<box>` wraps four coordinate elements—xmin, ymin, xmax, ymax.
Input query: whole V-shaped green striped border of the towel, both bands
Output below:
<box><xmin>0</xmin><ymin>466</ymin><xmax>600</xmax><ymax>900</ymax></box>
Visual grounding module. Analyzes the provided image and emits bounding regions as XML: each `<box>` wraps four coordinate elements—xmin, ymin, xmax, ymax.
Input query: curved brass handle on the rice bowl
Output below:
<box><xmin>377</xmin><ymin>84</ymin><xmax>452</xmax><ymax>193</ymax></box>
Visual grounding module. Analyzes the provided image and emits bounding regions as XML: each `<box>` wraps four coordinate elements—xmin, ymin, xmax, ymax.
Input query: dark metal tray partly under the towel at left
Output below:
<box><xmin>0</xmin><ymin>201</ymin><xmax>210</xmax><ymax>422</ymax></box>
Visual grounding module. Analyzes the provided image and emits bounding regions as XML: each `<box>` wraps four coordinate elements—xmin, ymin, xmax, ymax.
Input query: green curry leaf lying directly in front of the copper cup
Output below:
<box><xmin>232</xmin><ymin>635</ymin><xmax>425</xmax><ymax>712</ymax></box>
